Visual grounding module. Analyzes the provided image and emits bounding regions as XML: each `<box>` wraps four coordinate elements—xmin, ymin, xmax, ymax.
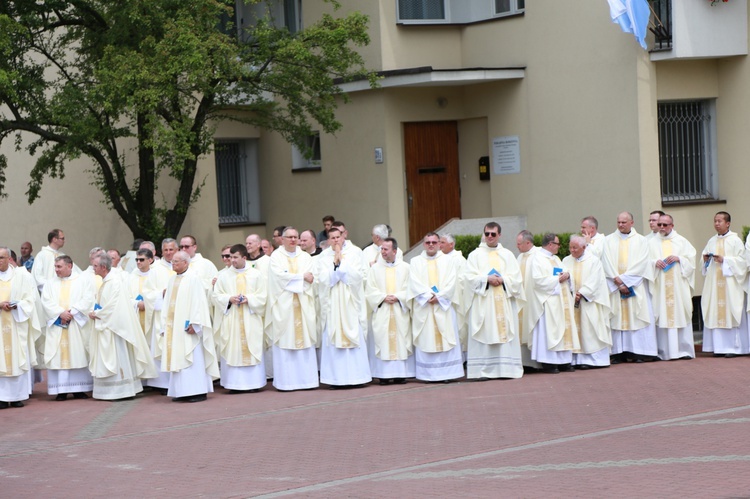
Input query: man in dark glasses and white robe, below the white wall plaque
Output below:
<box><xmin>465</xmin><ymin>222</ymin><xmax>525</xmax><ymax>379</ymax></box>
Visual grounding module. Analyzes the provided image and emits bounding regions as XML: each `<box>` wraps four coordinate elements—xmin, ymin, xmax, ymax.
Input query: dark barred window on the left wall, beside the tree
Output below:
<box><xmin>214</xmin><ymin>140</ymin><xmax>261</xmax><ymax>225</ymax></box>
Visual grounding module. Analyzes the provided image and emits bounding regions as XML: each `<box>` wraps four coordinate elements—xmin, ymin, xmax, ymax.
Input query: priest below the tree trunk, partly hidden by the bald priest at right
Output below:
<box><xmin>129</xmin><ymin>248</ymin><xmax>171</xmax><ymax>395</ymax></box>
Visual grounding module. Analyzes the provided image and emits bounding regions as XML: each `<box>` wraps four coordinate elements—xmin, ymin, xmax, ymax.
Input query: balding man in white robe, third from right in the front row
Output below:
<box><xmin>602</xmin><ymin>212</ymin><xmax>657</xmax><ymax>364</ymax></box>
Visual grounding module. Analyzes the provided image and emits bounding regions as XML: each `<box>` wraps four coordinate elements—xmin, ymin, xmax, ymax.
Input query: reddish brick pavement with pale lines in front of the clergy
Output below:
<box><xmin>0</xmin><ymin>354</ymin><xmax>750</xmax><ymax>498</ymax></box>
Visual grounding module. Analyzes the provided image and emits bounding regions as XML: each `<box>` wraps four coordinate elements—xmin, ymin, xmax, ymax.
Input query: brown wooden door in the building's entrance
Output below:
<box><xmin>404</xmin><ymin>121</ymin><xmax>461</xmax><ymax>245</ymax></box>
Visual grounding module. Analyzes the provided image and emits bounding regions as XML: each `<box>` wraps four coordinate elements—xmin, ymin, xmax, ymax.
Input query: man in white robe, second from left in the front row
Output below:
<box><xmin>42</xmin><ymin>255</ymin><xmax>96</xmax><ymax>400</ymax></box>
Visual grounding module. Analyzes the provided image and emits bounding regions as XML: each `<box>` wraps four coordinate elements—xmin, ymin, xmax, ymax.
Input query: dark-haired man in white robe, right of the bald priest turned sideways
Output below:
<box><xmin>212</xmin><ymin>244</ymin><xmax>266</xmax><ymax>393</ymax></box>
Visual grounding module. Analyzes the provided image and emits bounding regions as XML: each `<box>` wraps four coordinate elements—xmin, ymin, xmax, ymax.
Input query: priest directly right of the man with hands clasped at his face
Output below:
<box><xmin>365</xmin><ymin>237</ymin><xmax>416</xmax><ymax>385</ymax></box>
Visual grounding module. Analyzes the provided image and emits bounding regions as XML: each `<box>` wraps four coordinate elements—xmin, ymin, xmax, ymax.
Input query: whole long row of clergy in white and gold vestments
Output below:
<box><xmin>0</xmin><ymin>212</ymin><xmax>750</xmax><ymax>409</ymax></box>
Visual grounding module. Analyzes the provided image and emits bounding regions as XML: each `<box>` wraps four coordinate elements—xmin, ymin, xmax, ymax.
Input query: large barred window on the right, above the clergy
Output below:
<box><xmin>658</xmin><ymin>100</ymin><xmax>718</xmax><ymax>202</ymax></box>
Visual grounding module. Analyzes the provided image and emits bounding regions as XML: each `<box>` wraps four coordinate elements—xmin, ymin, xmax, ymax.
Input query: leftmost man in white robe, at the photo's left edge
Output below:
<box><xmin>0</xmin><ymin>247</ymin><xmax>42</xmax><ymax>409</ymax></box>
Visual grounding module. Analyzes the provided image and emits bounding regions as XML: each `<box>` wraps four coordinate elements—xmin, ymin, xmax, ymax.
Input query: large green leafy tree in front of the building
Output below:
<box><xmin>0</xmin><ymin>0</ymin><xmax>375</xmax><ymax>241</ymax></box>
